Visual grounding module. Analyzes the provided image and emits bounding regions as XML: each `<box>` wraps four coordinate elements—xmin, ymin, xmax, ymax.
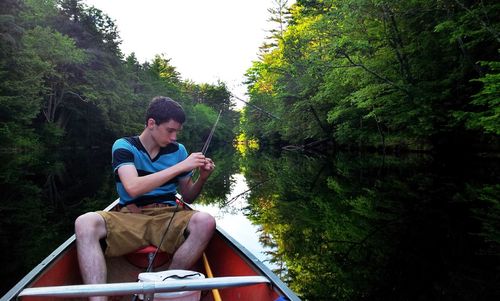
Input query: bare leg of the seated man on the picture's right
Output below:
<box><xmin>169</xmin><ymin>212</ymin><xmax>215</xmax><ymax>270</ymax></box>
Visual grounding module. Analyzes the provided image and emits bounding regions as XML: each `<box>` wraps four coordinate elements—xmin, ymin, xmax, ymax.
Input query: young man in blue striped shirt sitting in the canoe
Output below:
<box><xmin>75</xmin><ymin>97</ymin><xmax>215</xmax><ymax>300</ymax></box>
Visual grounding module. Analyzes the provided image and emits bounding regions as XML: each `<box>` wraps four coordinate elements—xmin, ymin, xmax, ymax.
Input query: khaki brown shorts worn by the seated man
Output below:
<box><xmin>97</xmin><ymin>207</ymin><xmax>197</xmax><ymax>257</ymax></box>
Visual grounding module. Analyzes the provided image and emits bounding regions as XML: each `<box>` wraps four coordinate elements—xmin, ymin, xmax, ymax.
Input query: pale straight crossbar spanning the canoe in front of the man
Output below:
<box><xmin>19</xmin><ymin>276</ymin><xmax>270</xmax><ymax>297</ymax></box>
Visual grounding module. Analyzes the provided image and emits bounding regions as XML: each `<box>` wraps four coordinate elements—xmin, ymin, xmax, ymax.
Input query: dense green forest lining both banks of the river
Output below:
<box><xmin>0</xmin><ymin>0</ymin><xmax>500</xmax><ymax>151</ymax></box>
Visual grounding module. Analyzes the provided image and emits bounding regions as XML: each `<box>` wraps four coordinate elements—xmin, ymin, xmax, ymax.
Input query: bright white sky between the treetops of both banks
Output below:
<box><xmin>84</xmin><ymin>0</ymin><xmax>278</xmax><ymax>102</ymax></box>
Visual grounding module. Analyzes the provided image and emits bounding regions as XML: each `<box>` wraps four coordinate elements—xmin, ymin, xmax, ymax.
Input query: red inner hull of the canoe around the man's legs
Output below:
<box><xmin>14</xmin><ymin>231</ymin><xmax>281</xmax><ymax>301</ymax></box>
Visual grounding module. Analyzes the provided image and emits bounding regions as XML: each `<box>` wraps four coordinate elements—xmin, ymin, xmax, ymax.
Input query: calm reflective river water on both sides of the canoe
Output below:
<box><xmin>0</xmin><ymin>149</ymin><xmax>500</xmax><ymax>300</ymax></box>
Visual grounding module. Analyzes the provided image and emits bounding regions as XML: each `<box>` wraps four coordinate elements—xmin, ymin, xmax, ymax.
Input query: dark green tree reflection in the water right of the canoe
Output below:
<box><xmin>237</xmin><ymin>153</ymin><xmax>500</xmax><ymax>300</ymax></box>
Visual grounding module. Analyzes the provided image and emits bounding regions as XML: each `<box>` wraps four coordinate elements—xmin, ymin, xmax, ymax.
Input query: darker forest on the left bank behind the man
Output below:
<box><xmin>0</xmin><ymin>0</ymin><xmax>239</xmax><ymax>150</ymax></box>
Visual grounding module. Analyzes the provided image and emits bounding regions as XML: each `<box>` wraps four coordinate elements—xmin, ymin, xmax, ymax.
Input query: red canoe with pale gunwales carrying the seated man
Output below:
<box><xmin>0</xmin><ymin>202</ymin><xmax>300</xmax><ymax>301</ymax></box>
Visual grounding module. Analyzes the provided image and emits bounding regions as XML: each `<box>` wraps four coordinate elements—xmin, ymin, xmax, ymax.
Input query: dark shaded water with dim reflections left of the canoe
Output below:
<box><xmin>0</xmin><ymin>150</ymin><xmax>114</xmax><ymax>295</ymax></box>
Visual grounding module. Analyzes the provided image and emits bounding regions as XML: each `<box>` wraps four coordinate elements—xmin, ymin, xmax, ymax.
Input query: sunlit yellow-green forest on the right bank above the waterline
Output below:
<box><xmin>242</xmin><ymin>0</ymin><xmax>500</xmax><ymax>151</ymax></box>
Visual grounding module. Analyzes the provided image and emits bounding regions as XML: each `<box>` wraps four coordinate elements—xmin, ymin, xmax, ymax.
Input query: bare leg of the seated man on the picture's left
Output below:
<box><xmin>75</xmin><ymin>212</ymin><xmax>107</xmax><ymax>301</ymax></box>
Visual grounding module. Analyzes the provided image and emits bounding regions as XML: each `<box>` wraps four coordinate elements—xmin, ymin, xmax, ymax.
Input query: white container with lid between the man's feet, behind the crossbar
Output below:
<box><xmin>139</xmin><ymin>270</ymin><xmax>205</xmax><ymax>301</ymax></box>
